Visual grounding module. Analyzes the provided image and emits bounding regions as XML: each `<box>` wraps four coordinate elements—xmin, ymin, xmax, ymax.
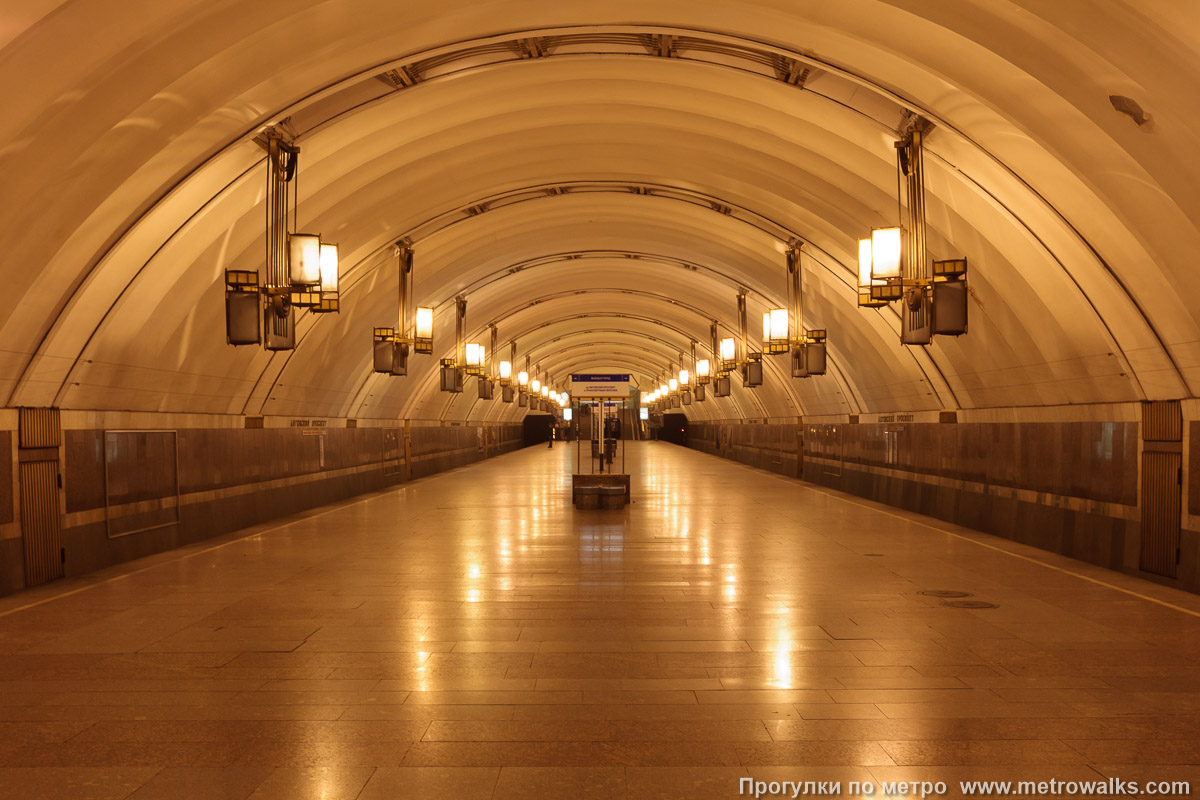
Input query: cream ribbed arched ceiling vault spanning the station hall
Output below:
<box><xmin>0</xmin><ymin>0</ymin><xmax>1200</xmax><ymax>419</ymax></box>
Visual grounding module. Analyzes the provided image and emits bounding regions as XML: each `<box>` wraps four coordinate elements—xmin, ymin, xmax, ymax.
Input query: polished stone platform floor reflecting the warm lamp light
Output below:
<box><xmin>0</xmin><ymin>443</ymin><xmax>1200</xmax><ymax>800</ymax></box>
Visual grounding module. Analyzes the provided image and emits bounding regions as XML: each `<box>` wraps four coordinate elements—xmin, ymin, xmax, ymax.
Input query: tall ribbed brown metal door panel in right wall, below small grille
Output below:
<box><xmin>1139</xmin><ymin>453</ymin><xmax>1183</xmax><ymax>578</ymax></box>
